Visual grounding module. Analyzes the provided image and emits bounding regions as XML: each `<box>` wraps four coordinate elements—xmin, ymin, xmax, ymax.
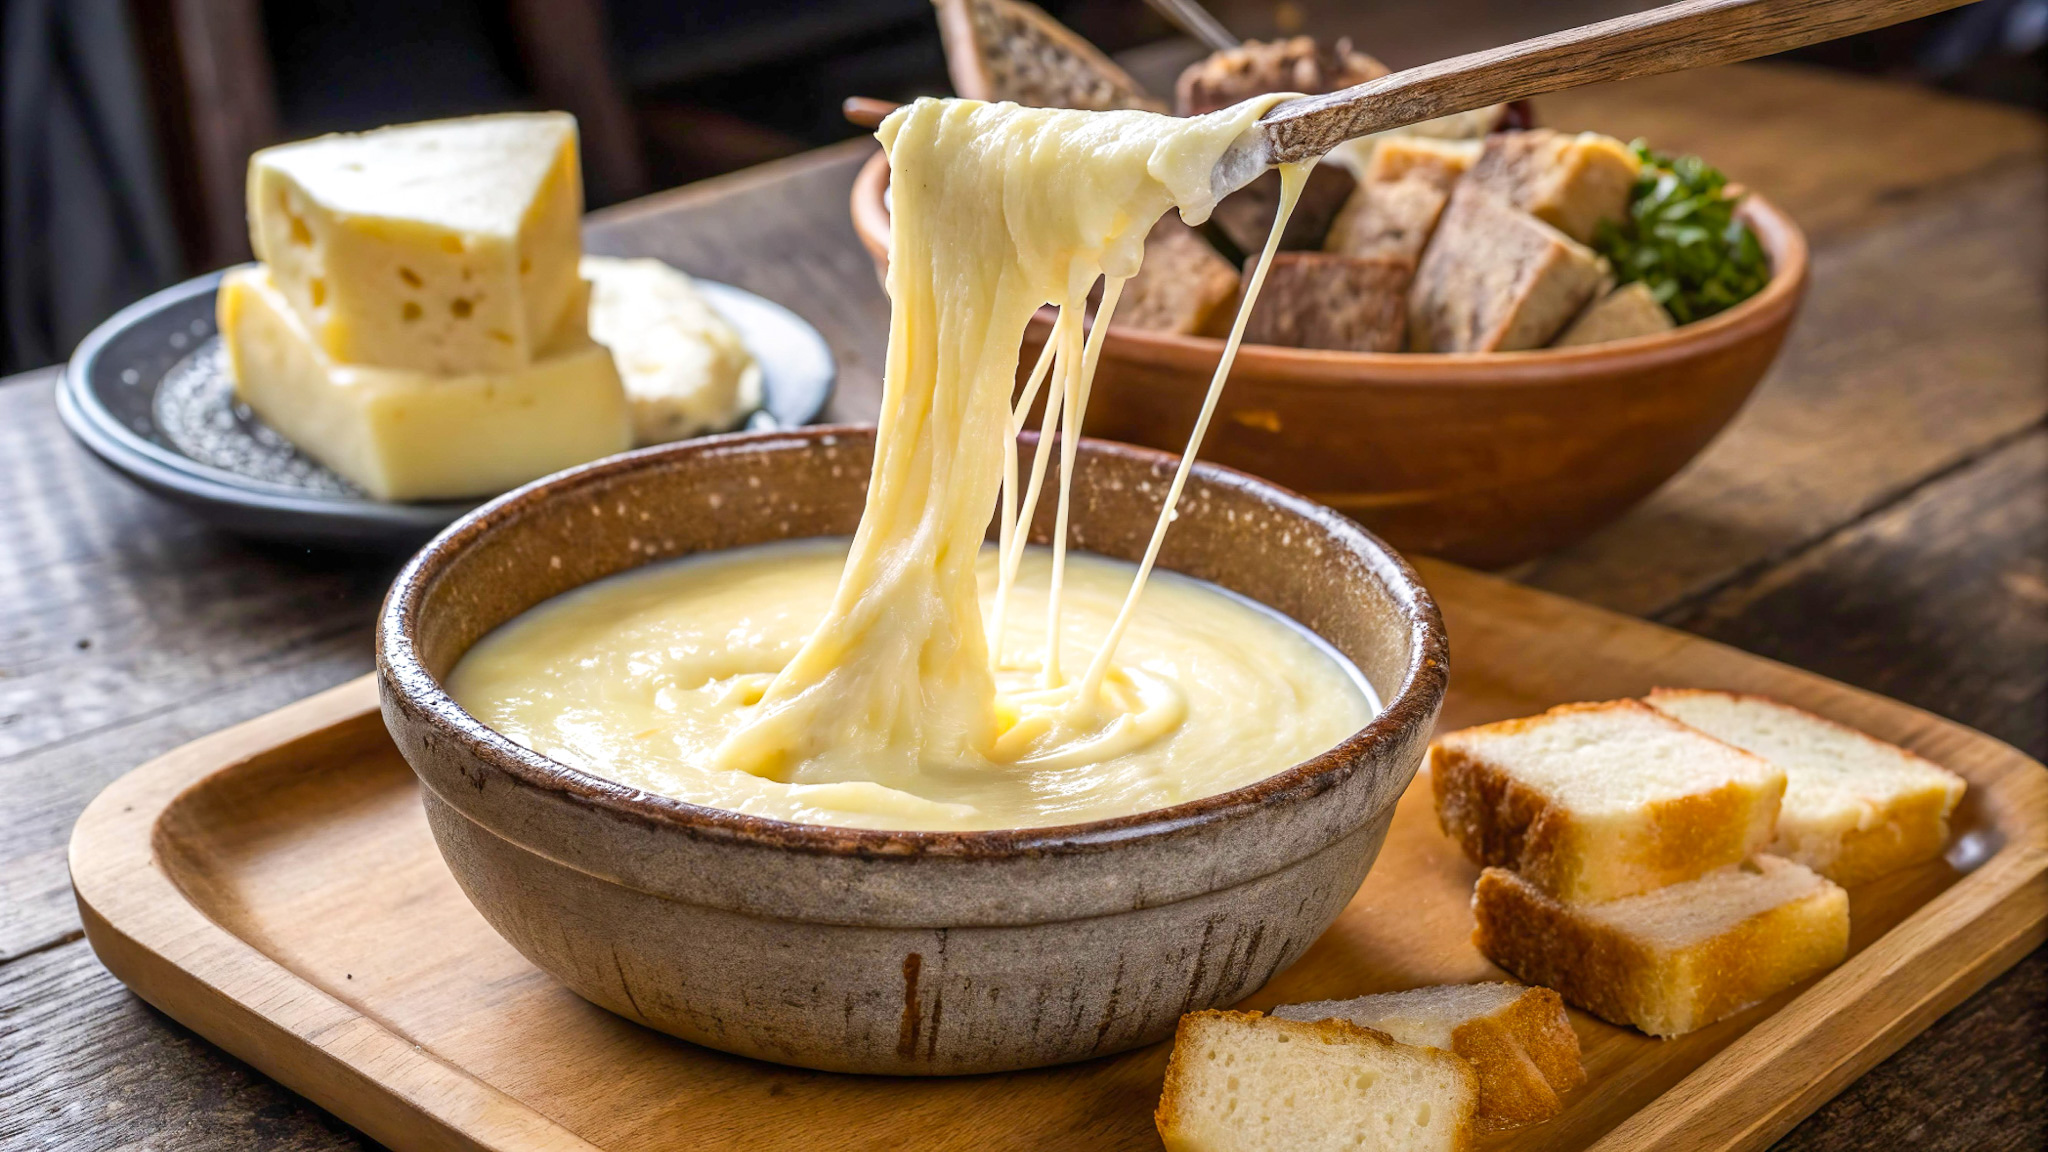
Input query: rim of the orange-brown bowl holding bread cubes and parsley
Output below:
<box><xmin>850</xmin><ymin>152</ymin><xmax>1810</xmax><ymax>387</ymax></box>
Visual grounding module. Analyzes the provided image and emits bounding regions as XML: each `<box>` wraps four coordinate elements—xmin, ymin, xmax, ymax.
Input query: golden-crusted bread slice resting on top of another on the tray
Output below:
<box><xmin>1430</xmin><ymin>699</ymin><xmax>1786</xmax><ymax>902</ymax></box>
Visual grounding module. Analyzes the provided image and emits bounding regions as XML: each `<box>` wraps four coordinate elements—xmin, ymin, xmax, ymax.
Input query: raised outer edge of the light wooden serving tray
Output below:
<box><xmin>70</xmin><ymin>562</ymin><xmax>2048</xmax><ymax>1152</ymax></box>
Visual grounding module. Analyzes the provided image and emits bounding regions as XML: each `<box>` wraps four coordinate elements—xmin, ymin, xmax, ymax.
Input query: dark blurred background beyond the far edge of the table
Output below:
<box><xmin>0</xmin><ymin>0</ymin><xmax>2048</xmax><ymax>371</ymax></box>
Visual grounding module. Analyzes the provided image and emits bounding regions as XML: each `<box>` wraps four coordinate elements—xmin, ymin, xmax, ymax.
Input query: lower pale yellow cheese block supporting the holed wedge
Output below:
<box><xmin>217</xmin><ymin>269</ymin><xmax>631</xmax><ymax>500</ymax></box>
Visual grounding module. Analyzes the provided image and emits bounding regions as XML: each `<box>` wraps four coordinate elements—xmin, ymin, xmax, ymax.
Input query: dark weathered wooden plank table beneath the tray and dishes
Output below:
<box><xmin>0</xmin><ymin>68</ymin><xmax>2048</xmax><ymax>1152</ymax></box>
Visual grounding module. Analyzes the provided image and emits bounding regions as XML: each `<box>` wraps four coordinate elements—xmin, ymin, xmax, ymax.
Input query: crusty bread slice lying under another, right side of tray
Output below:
<box><xmin>1473</xmin><ymin>857</ymin><xmax>1849</xmax><ymax>1037</ymax></box>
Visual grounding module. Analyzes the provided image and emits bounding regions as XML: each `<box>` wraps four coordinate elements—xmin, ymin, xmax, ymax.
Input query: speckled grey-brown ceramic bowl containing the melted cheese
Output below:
<box><xmin>377</xmin><ymin>428</ymin><xmax>1446</xmax><ymax>1074</ymax></box>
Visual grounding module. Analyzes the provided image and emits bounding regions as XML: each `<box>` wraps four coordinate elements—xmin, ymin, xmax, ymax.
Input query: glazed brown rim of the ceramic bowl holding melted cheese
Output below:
<box><xmin>377</xmin><ymin>424</ymin><xmax>1450</xmax><ymax>861</ymax></box>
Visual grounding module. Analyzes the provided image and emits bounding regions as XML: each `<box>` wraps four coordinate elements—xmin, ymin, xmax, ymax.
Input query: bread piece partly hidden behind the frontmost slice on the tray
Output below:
<box><xmin>1274</xmin><ymin>984</ymin><xmax>1585</xmax><ymax>1127</ymax></box>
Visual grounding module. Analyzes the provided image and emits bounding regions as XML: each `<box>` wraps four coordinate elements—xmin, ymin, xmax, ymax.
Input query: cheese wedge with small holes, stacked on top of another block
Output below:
<box><xmin>248</xmin><ymin>113</ymin><xmax>584</xmax><ymax>375</ymax></box>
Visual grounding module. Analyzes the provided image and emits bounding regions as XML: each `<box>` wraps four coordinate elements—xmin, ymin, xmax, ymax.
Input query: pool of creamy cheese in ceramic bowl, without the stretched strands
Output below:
<box><xmin>449</xmin><ymin>539</ymin><xmax>1374</xmax><ymax>830</ymax></box>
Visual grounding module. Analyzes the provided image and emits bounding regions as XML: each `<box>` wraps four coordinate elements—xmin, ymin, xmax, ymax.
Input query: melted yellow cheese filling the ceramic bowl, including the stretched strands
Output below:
<box><xmin>455</xmin><ymin>94</ymin><xmax>1370</xmax><ymax>828</ymax></box>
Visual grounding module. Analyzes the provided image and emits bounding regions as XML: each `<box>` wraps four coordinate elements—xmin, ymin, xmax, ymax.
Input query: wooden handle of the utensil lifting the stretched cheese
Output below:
<box><xmin>1257</xmin><ymin>0</ymin><xmax>1966</xmax><ymax>164</ymax></box>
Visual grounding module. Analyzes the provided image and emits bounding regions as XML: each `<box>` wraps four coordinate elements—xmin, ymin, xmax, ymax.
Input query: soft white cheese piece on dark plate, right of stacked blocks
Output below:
<box><xmin>582</xmin><ymin>256</ymin><xmax>762</xmax><ymax>445</ymax></box>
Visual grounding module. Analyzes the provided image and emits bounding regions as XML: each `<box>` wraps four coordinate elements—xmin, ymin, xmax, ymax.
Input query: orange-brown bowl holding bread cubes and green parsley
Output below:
<box><xmin>852</xmin><ymin>154</ymin><xmax>1806</xmax><ymax>568</ymax></box>
